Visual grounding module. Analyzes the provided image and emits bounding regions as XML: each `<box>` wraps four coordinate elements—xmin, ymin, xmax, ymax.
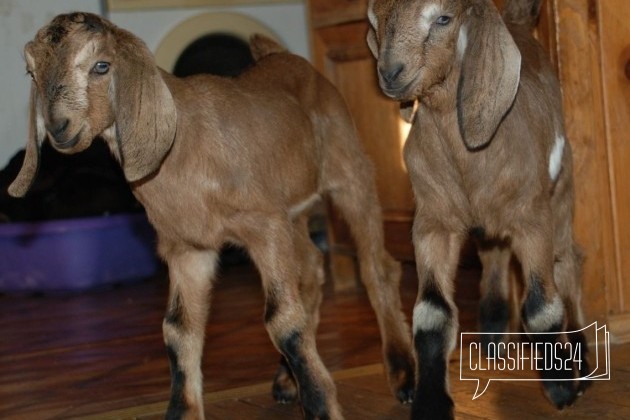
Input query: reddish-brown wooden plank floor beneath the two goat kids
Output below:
<box><xmin>0</xmin><ymin>258</ymin><xmax>630</xmax><ymax>420</ymax></box>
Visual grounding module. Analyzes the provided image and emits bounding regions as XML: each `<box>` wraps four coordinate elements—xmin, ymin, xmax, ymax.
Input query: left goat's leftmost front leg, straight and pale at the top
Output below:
<box><xmin>162</xmin><ymin>250</ymin><xmax>217</xmax><ymax>419</ymax></box>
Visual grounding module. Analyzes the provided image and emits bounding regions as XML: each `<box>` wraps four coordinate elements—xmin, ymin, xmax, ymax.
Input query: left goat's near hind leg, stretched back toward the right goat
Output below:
<box><xmin>318</xmin><ymin>88</ymin><xmax>415</xmax><ymax>402</ymax></box>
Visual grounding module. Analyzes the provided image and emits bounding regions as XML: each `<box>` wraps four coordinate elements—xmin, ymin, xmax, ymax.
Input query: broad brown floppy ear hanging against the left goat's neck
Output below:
<box><xmin>114</xmin><ymin>33</ymin><xmax>177</xmax><ymax>182</ymax></box>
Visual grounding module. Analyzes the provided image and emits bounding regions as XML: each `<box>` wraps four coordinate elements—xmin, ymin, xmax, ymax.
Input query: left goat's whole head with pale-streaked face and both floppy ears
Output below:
<box><xmin>9</xmin><ymin>13</ymin><xmax>177</xmax><ymax>196</ymax></box>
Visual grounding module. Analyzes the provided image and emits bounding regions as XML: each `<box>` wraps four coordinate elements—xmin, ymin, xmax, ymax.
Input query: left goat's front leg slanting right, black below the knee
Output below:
<box><xmin>243</xmin><ymin>216</ymin><xmax>343</xmax><ymax>419</ymax></box>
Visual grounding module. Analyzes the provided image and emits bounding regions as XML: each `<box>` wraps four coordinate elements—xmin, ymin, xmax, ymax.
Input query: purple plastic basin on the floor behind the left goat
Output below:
<box><xmin>0</xmin><ymin>214</ymin><xmax>159</xmax><ymax>292</ymax></box>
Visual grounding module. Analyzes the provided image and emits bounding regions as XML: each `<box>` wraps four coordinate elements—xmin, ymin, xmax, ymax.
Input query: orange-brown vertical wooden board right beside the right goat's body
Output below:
<box><xmin>554</xmin><ymin>0</ymin><xmax>619</xmax><ymax>323</ymax></box>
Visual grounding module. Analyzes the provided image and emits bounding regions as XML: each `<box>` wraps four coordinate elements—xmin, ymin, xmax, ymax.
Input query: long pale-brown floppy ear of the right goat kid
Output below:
<box><xmin>457</xmin><ymin>0</ymin><xmax>521</xmax><ymax>150</ymax></box>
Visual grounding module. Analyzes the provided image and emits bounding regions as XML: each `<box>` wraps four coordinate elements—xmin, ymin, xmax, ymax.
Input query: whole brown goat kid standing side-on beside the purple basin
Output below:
<box><xmin>10</xmin><ymin>13</ymin><xmax>415</xmax><ymax>419</ymax></box>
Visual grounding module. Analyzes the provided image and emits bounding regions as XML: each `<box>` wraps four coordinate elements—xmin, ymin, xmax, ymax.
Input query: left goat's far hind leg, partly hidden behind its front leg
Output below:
<box><xmin>272</xmin><ymin>215</ymin><xmax>324</xmax><ymax>403</ymax></box>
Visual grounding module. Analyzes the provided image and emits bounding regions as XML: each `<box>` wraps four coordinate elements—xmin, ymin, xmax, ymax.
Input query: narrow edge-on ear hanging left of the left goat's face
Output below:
<box><xmin>7</xmin><ymin>83</ymin><xmax>46</xmax><ymax>197</ymax></box>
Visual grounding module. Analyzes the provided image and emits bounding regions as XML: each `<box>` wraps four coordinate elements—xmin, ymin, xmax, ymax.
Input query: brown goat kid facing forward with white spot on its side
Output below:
<box><xmin>368</xmin><ymin>0</ymin><xmax>589</xmax><ymax>419</ymax></box>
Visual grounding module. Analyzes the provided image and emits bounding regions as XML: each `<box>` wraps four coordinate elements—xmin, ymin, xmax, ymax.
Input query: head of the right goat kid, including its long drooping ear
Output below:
<box><xmin>367</xmin><ymin>0</ymin><xmax>521</xmax><ymax>149</ymax></box>
